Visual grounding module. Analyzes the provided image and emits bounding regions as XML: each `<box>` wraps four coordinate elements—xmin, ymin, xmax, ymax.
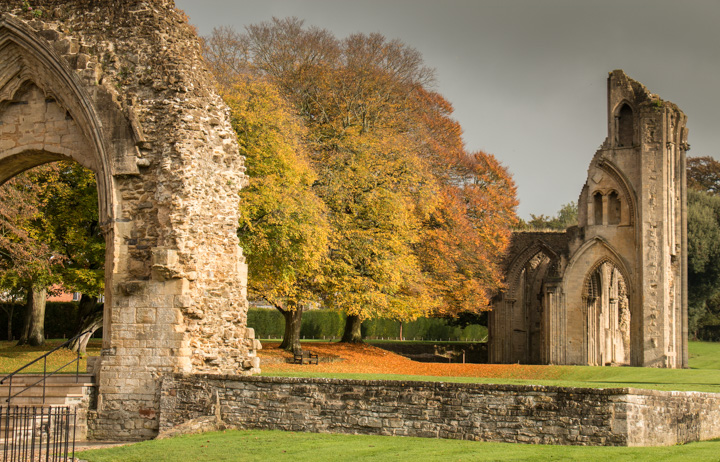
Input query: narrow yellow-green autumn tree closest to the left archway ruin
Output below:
<box><xmin>225</xmin><ymin>76</ymin><xmax>329</xmax><ymax>351</ymax></box>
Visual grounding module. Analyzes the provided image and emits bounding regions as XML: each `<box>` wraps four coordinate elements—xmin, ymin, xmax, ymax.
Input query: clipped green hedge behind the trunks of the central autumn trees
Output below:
<box><xmin>248</xmin><ymin>308</ymin><xmax>487</xmax><ymax>341</ymax></box>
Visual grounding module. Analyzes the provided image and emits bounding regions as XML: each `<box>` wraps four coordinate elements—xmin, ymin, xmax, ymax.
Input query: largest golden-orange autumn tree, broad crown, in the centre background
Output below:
<box><xmin>205</xmin><ymin>18</ymin><xmax>515</xmax><ymax>341</ymax></box>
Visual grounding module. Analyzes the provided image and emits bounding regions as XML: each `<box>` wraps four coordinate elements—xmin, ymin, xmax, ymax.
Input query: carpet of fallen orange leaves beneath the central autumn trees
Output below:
<box><xmin>258</xmin><ymin>342</ymin><xmax>560</xmax><ymax>380</ymax></box>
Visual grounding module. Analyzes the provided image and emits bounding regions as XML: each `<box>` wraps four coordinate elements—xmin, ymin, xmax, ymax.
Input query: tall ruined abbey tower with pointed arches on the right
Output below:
<box><xmin>489</xmin><ymin>70</ymin><xmax>688</xmax><ymax>368</ymax></box>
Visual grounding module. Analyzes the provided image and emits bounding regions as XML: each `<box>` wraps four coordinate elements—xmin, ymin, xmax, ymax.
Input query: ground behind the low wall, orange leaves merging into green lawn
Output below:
<box><xmin>259</xmin><ymin>342</ymin><xmax>720</xmax><ymax>393</ymax></box>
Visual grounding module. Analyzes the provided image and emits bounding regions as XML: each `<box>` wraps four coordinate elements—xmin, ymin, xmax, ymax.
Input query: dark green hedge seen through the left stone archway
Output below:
<box><xmin>0</xmin><ymin>302</ymin><xmax>102</xmax><ymax>340</ymax></box>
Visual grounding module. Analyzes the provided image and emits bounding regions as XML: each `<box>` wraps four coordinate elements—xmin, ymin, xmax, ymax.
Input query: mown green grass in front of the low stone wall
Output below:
<box><xmin>78</xmin><ymin>430</ymin><xmax>720</xmax><ymax>462</ymax></box>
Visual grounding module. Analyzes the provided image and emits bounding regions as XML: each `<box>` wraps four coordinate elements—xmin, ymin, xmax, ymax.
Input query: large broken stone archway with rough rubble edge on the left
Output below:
<box><xmin>0</xmin><ymin>0</ymin><xmax>259</xmax><ymax>439</ymax></box>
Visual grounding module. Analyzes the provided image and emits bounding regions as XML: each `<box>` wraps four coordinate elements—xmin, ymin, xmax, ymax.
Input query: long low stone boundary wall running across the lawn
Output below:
<box><xmin>160</xmin><ymin>374</ymin><xmax>720</xmax><ymax>446</ymax></box>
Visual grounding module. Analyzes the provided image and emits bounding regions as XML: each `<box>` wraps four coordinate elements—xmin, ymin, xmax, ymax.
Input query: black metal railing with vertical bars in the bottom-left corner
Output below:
<box><xmin>0</xmin><ymin>405</ymin><xmax>77</xmax><ymax>462</ymax></box>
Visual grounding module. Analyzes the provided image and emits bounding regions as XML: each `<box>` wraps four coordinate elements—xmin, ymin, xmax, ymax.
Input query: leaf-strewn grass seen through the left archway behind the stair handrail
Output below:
<box><xmin>0</xmin><ymin>339</ymin><xmax>102</xmax><ymax>375</ymax></box>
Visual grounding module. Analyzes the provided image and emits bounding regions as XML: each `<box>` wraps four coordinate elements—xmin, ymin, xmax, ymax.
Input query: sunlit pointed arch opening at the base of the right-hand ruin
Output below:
<box><xmin>583</xmin><ymin>260</ymin><xmax>630</xmax><ymax>366</ymax></box>
